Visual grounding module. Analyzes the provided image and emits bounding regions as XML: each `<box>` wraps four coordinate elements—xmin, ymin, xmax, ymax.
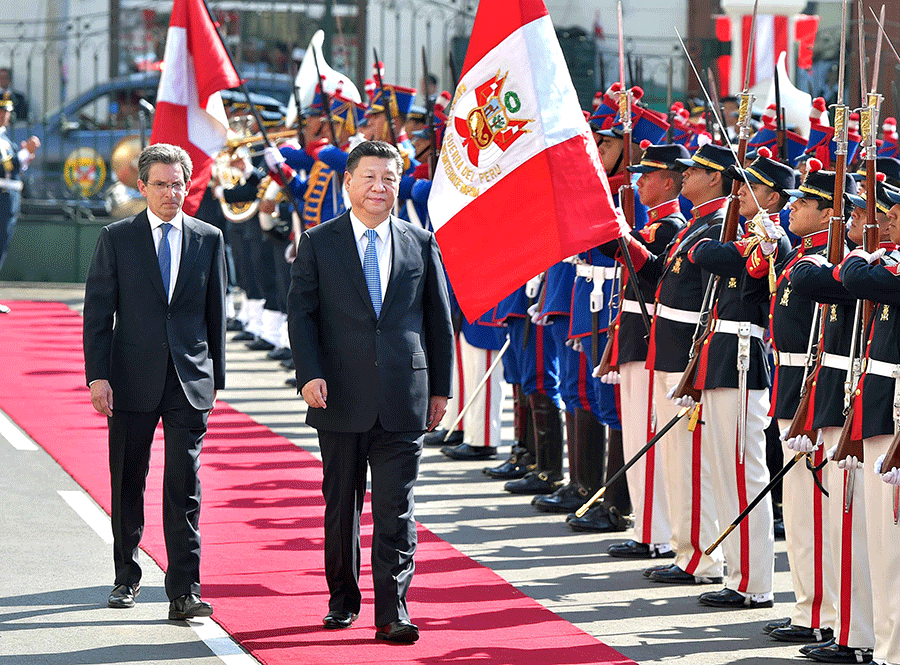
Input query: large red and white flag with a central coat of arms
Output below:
<box><xmin>428</xmin><ymin>0</ymin><xmax>625</xmax><ymax>321</ymax></box>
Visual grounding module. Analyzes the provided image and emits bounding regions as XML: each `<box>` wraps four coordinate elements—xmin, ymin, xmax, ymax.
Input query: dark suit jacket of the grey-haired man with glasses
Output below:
<box><xmin>84</xmin><ymin>211</ymin><xmax>225</xmax><ymax>412</ymax></box>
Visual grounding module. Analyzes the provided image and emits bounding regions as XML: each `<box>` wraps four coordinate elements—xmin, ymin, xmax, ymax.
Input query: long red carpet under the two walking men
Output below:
<box><xmin>0</xmin><ymin>302</ymin><xmax>633</xmax><ymax>665</ymax></box>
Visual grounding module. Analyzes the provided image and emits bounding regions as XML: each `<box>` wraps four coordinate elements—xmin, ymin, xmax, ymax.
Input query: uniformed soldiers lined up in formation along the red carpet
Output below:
<box><xmin>208</xmin><ymin>54</ymin><xmax>900</xmax><ymax>665</ymax></box>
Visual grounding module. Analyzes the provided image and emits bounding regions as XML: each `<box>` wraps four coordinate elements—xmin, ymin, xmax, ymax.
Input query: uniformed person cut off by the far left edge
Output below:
<box><xmin>0</xmin><ymin>91</ymin><xmax>41</xmax><ymax>286</ymax></box>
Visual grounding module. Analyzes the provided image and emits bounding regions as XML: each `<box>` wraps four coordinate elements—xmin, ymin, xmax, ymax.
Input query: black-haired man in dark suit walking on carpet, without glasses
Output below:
<box><xmin>288</xmin><ymin>141</ymin><xmax>453</xmax><ymax>642</ymax></box>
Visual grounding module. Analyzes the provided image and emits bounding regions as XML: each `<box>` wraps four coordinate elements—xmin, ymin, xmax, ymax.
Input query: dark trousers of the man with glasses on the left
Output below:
<box><xmin>108</xmin><ymin>358</ymin><xmax>209</xmax><ymax>600</ymax></box>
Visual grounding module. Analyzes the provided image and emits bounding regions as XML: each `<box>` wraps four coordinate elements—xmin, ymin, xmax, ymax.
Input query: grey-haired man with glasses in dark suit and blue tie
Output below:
<box><xmin>84</xmin><ymin>143</ymin><xmax>225</xmax><ymax>620</ymax></box>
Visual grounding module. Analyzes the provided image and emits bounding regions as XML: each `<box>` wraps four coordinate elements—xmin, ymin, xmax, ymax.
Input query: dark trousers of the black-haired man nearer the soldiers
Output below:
<box><xmin>319</xmin><ymin>421</ymin><xmax>422</xmax><ymax>626</ymax></box>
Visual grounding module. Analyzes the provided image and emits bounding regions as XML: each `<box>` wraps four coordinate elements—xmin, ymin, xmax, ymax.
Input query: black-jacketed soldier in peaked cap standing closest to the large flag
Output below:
<box><xmin>597</xmin><ymin>141</ymin><xmax>690</xmax><ymax>559</ymax></box>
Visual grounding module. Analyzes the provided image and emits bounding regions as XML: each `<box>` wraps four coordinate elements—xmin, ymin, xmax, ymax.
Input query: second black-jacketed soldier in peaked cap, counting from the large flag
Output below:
<box><xmin>626</xmin><ymin>144</ymin><xmax>734</xmax><ymax>584</ymax></box>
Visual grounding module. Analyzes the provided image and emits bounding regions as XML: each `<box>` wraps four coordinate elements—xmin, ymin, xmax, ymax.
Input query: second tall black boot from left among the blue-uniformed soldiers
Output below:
<box><xmin>503</xmin><ymin>393</ymin><xmax>563</xmax><ymax>494</ymax></box>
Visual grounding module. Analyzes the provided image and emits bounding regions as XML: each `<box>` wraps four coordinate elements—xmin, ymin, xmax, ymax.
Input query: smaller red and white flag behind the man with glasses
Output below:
<box><xmin>150</xmin><ymin>0</ymin><xmax>241</xmax><ymax>215</ymax></box>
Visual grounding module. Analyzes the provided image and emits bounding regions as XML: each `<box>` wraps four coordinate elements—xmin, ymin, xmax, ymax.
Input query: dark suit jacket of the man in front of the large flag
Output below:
<box><xmin>288</xmin><ymin>213</ymin><xmax>453</xmax><ymax>432</ymax></box>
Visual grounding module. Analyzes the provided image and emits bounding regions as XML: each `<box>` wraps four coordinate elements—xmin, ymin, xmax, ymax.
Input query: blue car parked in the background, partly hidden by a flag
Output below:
<box><xmin>10</xmin><ymin>71</ymin><xmax>292</xmax><ymax>216</ymax></box>
